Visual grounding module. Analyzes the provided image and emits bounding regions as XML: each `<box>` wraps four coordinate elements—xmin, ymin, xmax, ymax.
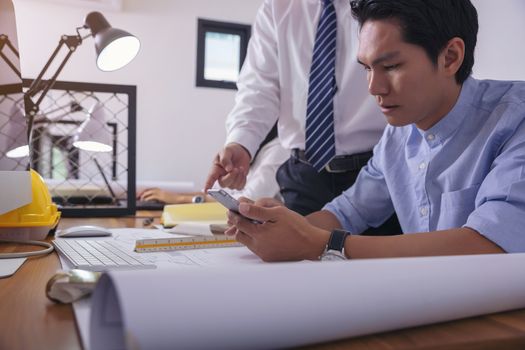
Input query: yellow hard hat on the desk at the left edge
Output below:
<box><xmin>0</xmin><ymin>169</ymin><xmax>60</xmax><ymax>239</ymax></box>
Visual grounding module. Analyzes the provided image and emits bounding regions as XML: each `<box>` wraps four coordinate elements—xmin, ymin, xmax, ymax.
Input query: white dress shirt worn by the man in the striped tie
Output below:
<box><xmin>226</xmin><ymin>0</ymin><xmax>386</xmax><ymax>155</ymax></box>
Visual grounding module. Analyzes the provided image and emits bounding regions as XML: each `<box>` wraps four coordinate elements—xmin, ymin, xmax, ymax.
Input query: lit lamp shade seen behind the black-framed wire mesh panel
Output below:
<box><xmin>73</xmin><ymin>102</ymin><xmax>113</xmax><ymax>152</ymax></box>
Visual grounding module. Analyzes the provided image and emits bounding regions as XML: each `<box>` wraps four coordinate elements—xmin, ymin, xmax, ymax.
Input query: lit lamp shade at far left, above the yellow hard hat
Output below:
<box><xmin>3</xmin><ymin>104</ymin><xmax>29</xmax><ymax>158</ymax></box>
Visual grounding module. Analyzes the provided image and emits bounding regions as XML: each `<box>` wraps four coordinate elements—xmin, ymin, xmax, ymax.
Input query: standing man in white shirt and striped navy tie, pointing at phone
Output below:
<box><xmin>205</xmin><ymin>0</ymin><xmax>392</xmax><ymax>227</ymax></box>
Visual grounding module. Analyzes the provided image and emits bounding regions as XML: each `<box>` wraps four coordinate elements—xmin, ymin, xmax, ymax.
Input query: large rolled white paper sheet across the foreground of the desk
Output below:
<box><xmin>90</xmin><ymin>254</ymin><xmax>525</xmax><ymax>349</ymax></box>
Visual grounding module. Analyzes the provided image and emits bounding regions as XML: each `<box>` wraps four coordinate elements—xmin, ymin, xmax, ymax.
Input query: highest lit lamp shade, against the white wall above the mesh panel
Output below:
<box><xmin>84</xmin><ymin>12</ymin><xmax>140</xmax><ymax>72</ymax></box>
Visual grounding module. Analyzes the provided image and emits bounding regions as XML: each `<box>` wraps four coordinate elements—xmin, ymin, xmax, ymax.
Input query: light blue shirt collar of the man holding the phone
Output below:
<box><xmin>413</xmin><ymin>77</ymin><xmax>478</xmax><ymax>147</ymax></box>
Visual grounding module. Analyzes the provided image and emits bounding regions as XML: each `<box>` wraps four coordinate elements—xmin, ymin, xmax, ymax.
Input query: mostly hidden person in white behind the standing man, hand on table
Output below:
<box><xmin>137</xmin><ymin>125</ymin><xmax>289</xmax><ymax>204</ymax></box>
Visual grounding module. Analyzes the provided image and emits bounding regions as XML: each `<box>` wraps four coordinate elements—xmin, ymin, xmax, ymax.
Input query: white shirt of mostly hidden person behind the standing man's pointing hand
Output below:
<box><xmin>228</xmin><ymin>138</ymin><xmax>290</xmax><ymax>200</ymax></box>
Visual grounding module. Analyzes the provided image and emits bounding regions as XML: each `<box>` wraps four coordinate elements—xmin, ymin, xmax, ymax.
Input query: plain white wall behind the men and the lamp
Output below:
<box><xmin>9</xmin><ymin>0</ymin><xmax>525</xmax><ymax>186</ymax></box>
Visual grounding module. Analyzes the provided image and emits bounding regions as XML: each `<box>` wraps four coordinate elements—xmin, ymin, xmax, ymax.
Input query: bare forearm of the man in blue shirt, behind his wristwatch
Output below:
<box><xmin>345</xmin><ymin>228</ymin><xmax>505</xmax><ymax>259</ymax></box>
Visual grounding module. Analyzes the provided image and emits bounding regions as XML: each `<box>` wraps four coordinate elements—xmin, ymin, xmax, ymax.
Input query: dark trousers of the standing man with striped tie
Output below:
<box><xmin>276</xmin><ymin>152</ymin><xmax>401</xmax><ymax>235</ymax></box>
